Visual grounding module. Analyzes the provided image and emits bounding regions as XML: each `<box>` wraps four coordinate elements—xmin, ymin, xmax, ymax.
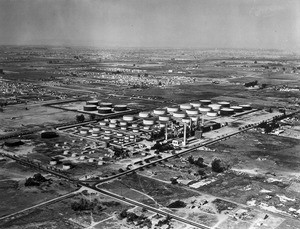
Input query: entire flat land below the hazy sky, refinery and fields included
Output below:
<box><xmin>0</xmin><ymin>44</ymin><xmax>300</xmax><ymax>229</ymax></box>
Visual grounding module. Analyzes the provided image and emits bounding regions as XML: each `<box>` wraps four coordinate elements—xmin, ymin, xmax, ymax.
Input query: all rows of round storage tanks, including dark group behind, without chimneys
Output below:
<box><xmin>78</xmin><ymin>100</ymin><xmax>252</xmax><ymax>143</ymax></box>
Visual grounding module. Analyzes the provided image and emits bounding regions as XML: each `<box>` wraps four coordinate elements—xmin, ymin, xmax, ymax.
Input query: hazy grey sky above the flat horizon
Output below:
<box><xmin>0</xmin><ymin>0</ymin><xmax>300</xmax><ymax>50</ymax></box>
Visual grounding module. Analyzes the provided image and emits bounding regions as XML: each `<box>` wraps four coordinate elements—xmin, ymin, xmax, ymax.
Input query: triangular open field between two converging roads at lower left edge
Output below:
<box><xmin>0</xmin><ymin>157</ymin><xmax>76</xmax><ymax>217</ymax></box>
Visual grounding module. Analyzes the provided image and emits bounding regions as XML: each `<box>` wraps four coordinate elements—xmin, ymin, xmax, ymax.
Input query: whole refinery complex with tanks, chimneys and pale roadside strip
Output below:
<box><xmin>50</xmin><ymin>96</ymin><xmax>285</xmax><ymax>170</ymax></box>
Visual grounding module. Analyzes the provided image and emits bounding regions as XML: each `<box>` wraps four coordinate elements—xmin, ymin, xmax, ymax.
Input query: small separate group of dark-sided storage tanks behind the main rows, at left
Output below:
<box><xmin>83</xmin><ymin>100</ymin><xmax>127</xmax><ymax>114</ymax></box>
